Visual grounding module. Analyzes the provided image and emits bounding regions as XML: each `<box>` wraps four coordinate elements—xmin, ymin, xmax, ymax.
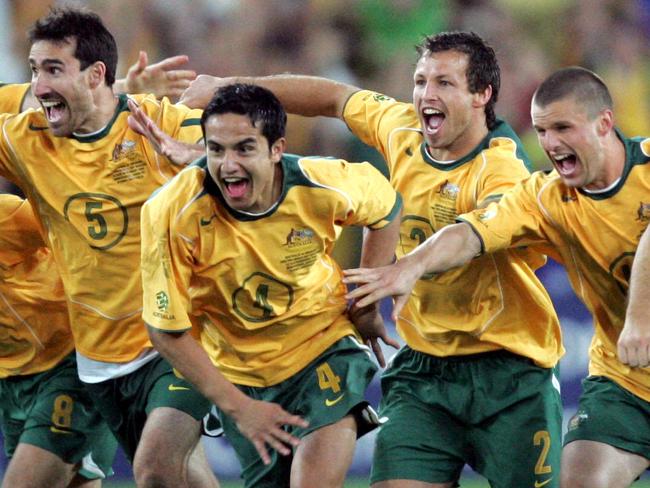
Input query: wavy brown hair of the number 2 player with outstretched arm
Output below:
<box><xmin>415</xmin><ymin>31</ymin><xmax>501</xmax><ymax>129</ymax></box>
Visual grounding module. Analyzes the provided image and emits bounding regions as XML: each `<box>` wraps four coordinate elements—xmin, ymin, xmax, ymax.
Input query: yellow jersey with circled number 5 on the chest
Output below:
<box><xmin>0</xmin><ymin>95</ymin><xmax>201</xmax><ymax>363</ymax></box>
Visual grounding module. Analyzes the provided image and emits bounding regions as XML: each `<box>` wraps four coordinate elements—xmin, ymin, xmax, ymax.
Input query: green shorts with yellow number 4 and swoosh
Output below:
<box><xmin>220</xmin><ymin>337</ymin><xmax>378</xmax><ymax>488</ymax></box>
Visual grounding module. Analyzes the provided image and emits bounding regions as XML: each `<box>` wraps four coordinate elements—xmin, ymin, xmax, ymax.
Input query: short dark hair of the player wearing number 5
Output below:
<box><xmin>29</xmin><ymin>6</ymin><xmax>117</xmax><ymax>86</ymax></box>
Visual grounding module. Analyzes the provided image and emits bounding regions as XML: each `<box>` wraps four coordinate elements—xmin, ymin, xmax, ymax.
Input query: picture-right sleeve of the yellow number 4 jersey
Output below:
<box><xmin>303</xmin><ymin>158</ymin><xmax>402</xmax><ymax>229</ymax></box>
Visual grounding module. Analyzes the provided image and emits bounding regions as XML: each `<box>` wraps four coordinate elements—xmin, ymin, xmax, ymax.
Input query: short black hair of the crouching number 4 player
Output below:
<box><xmin>201</xmin><ymin>83</ymin><xmax>287</xmax><ymax>148</ymax></box>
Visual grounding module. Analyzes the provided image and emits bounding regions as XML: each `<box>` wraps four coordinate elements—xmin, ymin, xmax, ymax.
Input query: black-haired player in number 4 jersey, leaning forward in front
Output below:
<box><xmin>137</xmin><ymin>84</ymin><xmax>401</xmax><ymax>488</ymax></box>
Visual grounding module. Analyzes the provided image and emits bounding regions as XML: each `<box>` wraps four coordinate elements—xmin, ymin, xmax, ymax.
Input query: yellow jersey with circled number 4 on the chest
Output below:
<box><xmin>142</xmin><ymin>154</ymin><xmax>401</xmax><ymax>386</ymax></box>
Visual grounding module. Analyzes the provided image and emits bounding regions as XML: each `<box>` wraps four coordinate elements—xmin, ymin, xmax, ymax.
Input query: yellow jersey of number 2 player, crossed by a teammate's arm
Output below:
<box><xmin>344</xmin><ymin>91</ymin><xmax>564</xmax><ymax>367</ymax></box>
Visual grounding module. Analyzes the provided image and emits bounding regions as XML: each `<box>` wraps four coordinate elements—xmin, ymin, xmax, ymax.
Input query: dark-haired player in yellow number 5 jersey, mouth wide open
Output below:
<box><xmin>0</xmin><ymin>8</ymin><xmax>298</xmax><ymax>487</ymax></box>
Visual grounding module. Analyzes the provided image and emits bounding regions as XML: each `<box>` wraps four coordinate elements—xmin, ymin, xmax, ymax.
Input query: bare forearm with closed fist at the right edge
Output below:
<box><xmin>618</xmin><ymin>228</ymin><xmax>650</xmax><ymax>368</ymax></box>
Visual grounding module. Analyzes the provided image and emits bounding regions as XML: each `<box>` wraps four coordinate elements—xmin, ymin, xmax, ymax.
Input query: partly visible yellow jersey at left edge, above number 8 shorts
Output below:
<box><xmin>0</xmin><ymin>194</ymin><xmax>73</xmax><ymax>378</ymax></box>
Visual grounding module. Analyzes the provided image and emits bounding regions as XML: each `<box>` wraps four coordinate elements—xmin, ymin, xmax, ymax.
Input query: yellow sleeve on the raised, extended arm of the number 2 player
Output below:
<box><xmin>343</xmin><ymin>90</ymin><xmax>417</xmax><ymax>170</ymax></box>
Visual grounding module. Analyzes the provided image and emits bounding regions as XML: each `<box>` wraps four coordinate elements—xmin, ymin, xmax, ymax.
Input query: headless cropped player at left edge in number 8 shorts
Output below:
<box><xmin>0</xmin><ymin>195</ymin><xmax>117</xmax><ymax>488</ymax></box>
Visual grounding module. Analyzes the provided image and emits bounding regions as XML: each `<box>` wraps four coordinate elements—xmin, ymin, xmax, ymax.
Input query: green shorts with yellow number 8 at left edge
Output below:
<box><xmin>0</xmin><ymin>353</ymin><xmax>117</xmax><ymax>479</ymax></box>
